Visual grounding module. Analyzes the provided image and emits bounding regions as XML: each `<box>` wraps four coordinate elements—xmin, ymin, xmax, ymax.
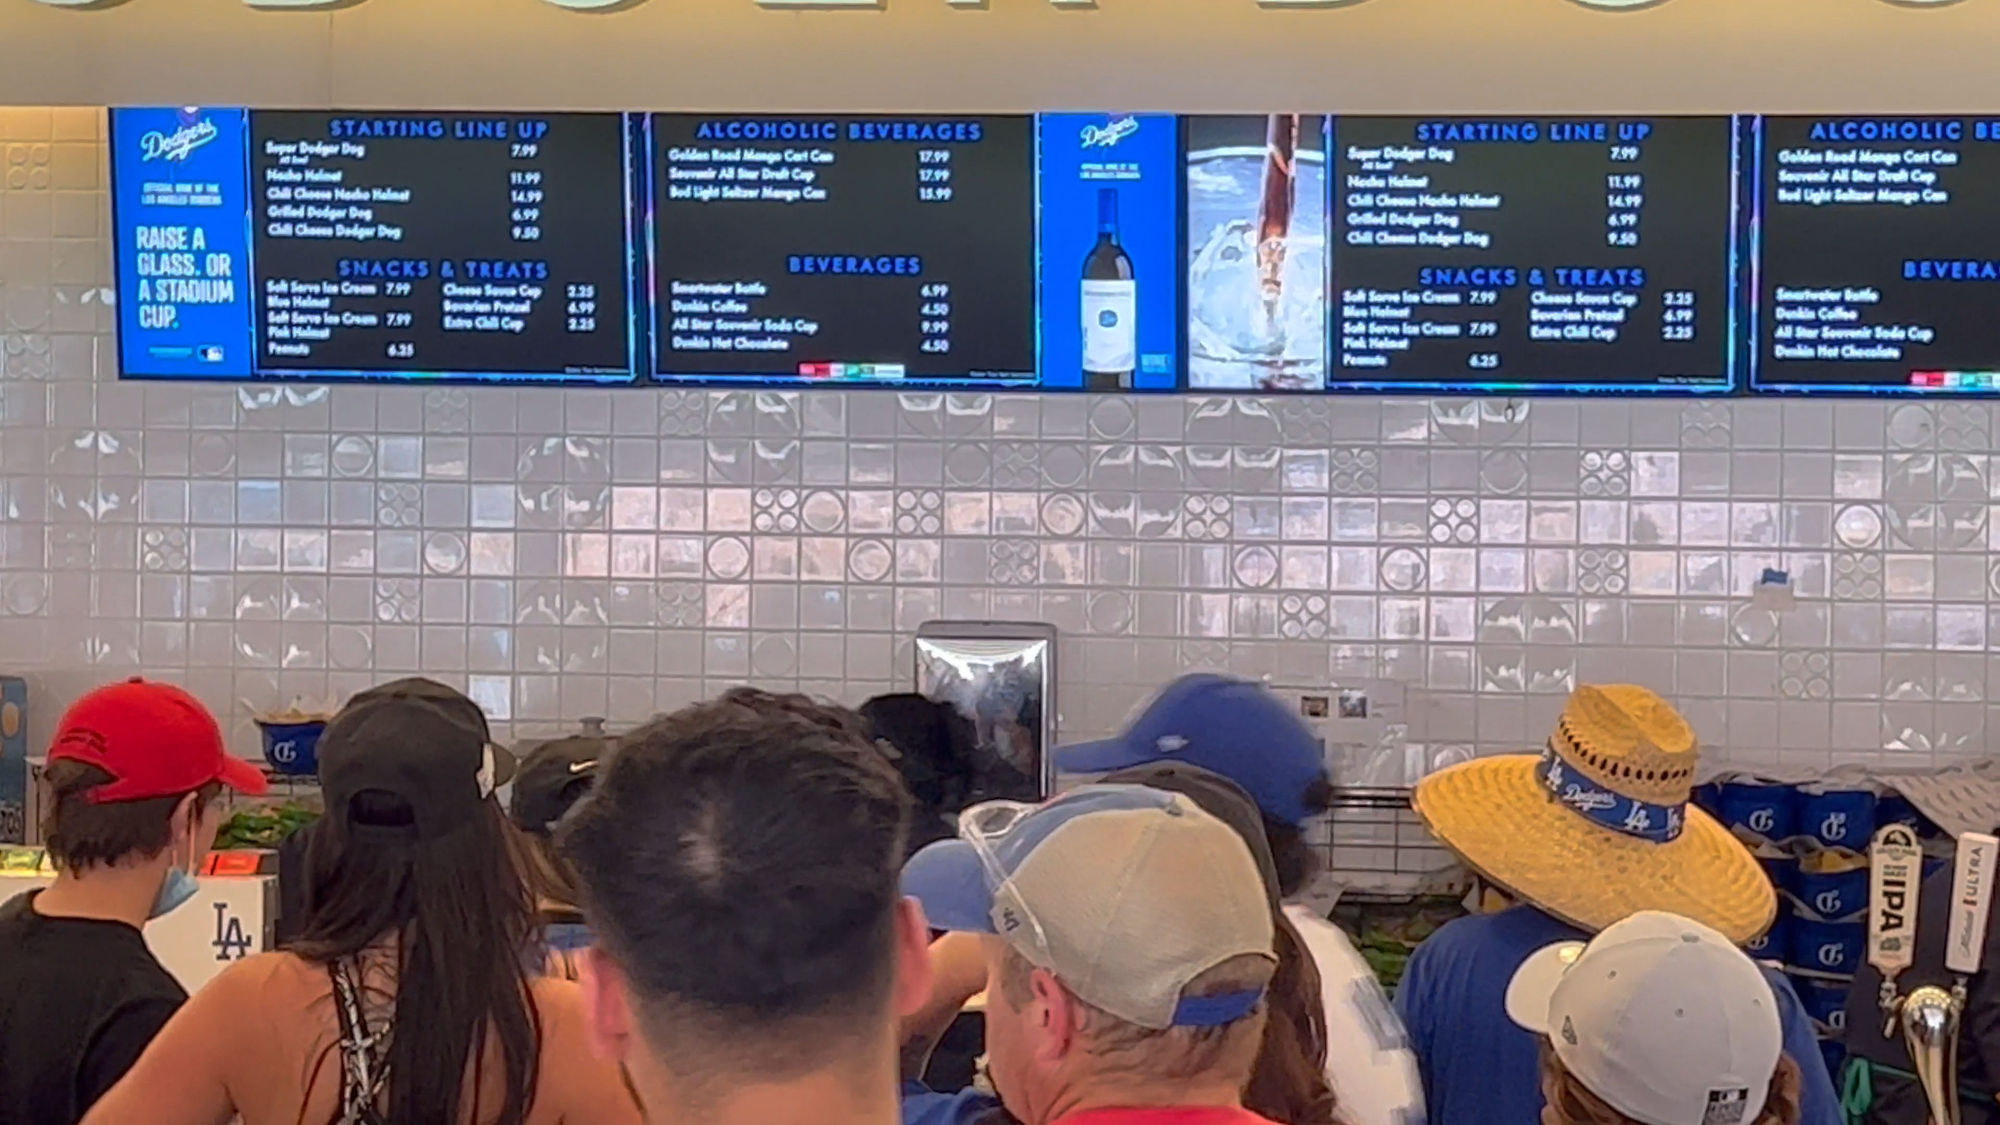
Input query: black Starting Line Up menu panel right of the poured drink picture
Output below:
<box><xmin>1328</xmin><ymin>116</ymin><xmax>1738</xmax><ymax>390</ymax></box>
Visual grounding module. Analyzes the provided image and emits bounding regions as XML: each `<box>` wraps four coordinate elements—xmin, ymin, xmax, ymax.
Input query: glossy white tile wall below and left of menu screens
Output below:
<box><xmin>0</xmin><ymin>108</ymin><xmax>2000</xmax><ymax>769</ymax></box>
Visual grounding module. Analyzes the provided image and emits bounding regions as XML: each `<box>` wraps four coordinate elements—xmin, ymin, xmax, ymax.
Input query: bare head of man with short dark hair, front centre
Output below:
<box><xmin>556</xmin><ymin>693</ymin><xmax>930</xmax><ymax>1113</ymax></box>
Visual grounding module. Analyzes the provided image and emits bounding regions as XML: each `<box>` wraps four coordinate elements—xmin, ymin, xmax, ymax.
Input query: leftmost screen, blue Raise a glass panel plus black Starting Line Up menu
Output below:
<box><xmin>112</xmin><ymin>108</ymin><xmax>638</xmax><ymax>382</ymax></box>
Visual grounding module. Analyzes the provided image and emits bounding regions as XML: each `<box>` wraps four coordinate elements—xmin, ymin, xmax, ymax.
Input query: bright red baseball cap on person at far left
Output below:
<box><xmin>48</xmin><ymin>679</ymin><xmax>270</xmax><ymax>805</ymax></box>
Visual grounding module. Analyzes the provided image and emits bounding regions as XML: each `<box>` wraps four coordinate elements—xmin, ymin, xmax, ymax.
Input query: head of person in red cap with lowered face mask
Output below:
<box><xmin>42</xmin><ymin>681</ymin><xmax>266</xmax><ymax>909</ymax></box>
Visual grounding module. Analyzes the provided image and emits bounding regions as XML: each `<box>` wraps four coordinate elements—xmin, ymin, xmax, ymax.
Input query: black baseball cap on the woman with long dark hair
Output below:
<box><xmin>320</xmin><ymin>679</ymin><xmax>514</xmax><ymax>841</ymax></box>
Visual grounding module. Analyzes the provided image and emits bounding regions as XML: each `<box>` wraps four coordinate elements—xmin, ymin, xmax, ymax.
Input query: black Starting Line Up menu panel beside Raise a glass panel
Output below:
<box><xmin>250</xmin><ymin>110</ymin><xmax>636</xmax><ymax>378</ymax></box>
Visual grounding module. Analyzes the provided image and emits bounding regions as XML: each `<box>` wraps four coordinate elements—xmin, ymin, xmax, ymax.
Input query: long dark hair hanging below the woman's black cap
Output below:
<box><xmin>288</xmin><ymin>789</ymin><xmax>542</xmax><ymax>1125</ymax></box>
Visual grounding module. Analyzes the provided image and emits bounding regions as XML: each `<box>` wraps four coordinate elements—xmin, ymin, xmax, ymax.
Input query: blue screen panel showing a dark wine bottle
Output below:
<box><xmin>1040</xmin><ymin>114</ymin><xmax>1182</xmax><ymax>390</ymax></box>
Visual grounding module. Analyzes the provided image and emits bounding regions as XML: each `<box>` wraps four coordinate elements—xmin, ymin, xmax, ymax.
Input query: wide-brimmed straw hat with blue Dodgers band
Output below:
<box><xmin>1412</xmin><ymin>685</ymin><xmax>1778</xmax><ymax>943</ymax></box>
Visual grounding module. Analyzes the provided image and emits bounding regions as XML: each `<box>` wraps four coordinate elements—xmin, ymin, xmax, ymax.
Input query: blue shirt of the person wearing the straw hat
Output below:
<box><xmin>1392</xmin><ymin>907</ymin><xmax>1842</xmax><ymax>1125</ymax></box>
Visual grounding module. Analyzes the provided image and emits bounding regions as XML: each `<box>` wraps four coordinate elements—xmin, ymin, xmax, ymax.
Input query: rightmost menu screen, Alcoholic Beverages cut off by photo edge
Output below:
<box><xmin>1752</xmin><ymin>116</ymin><xmax>2000</xmax><ymax>392</ymax></box>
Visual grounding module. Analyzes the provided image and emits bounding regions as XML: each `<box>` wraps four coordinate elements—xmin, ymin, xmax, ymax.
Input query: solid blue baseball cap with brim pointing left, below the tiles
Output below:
<box><xmin>1056</xmin><ymin>673</ymin><xmax>1326</xmax><ymax>825</ymax></box>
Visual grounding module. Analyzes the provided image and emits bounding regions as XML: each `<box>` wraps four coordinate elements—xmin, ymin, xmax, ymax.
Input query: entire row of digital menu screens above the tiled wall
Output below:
<box><xmin>110</xmin><ymin>106</ymin><xmax>2000</xmax><ymax>394</ymax></box>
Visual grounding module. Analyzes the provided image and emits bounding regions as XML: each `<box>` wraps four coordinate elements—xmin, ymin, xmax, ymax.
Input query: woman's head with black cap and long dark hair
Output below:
<box><xmin>288</xmin><ymin>681</ymin><xmax>540</xmax><ymax>1125</ymax></box>
